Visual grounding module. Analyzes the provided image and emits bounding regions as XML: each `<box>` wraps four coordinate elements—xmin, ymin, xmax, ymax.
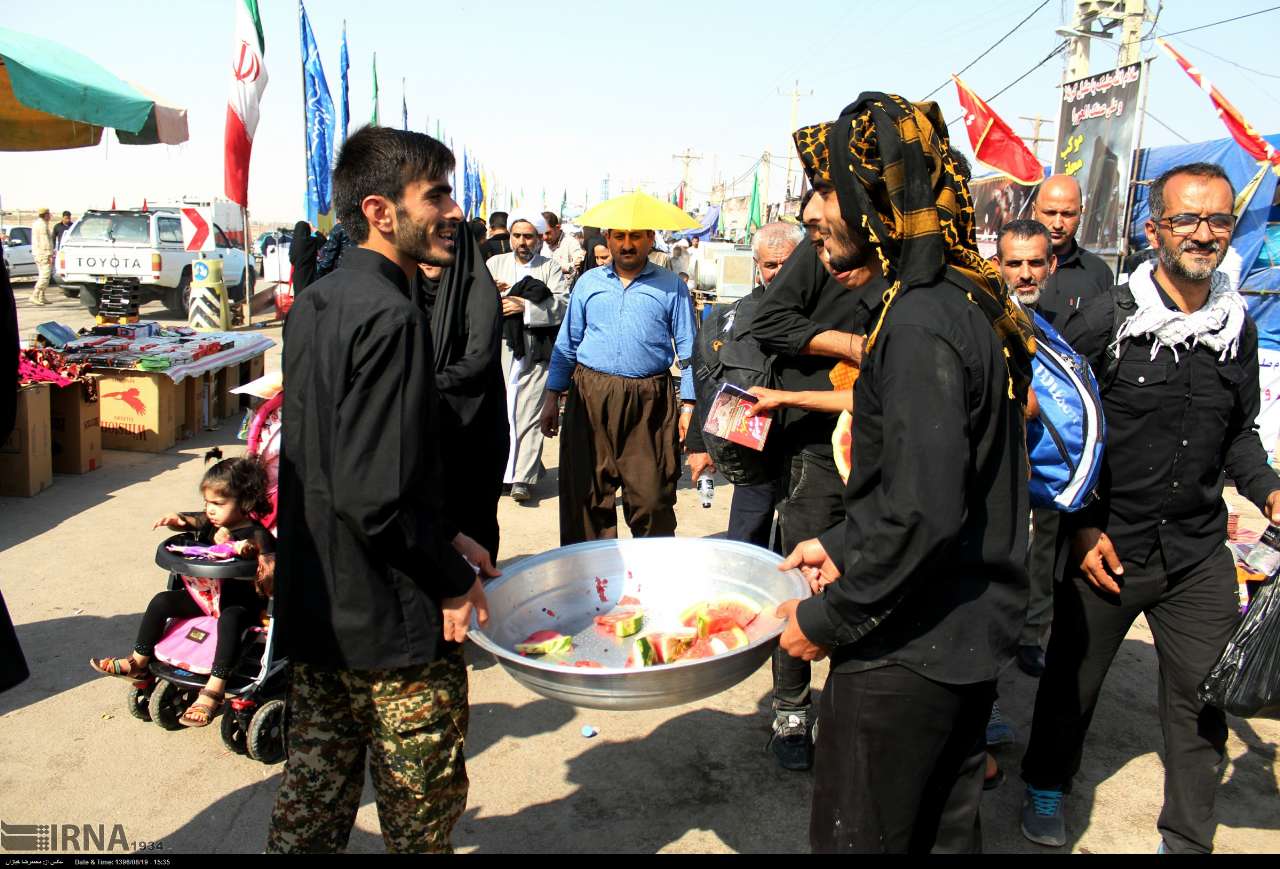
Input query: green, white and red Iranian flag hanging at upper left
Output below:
<box><xmin>227</xmin><ymin>0</ymin><xmax>266</xmax><ymax>207</ymax></box>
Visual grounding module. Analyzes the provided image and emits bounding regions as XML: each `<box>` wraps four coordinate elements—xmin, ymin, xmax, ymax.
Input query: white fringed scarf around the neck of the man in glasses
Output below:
<box><xmin>1115</xmin><ymin>261</ymin><xmax>1245</xmax><ymax>362</ymax></box>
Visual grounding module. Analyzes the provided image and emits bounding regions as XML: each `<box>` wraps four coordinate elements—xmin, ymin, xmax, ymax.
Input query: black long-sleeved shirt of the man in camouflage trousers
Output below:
<box><xmin>275</xmin><ymin>248</ymin><xmax>476</xmax><ymax>669</ymax></box>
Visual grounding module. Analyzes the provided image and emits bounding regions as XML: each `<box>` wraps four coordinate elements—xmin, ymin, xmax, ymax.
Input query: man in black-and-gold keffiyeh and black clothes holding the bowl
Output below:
<box><xmin>780</xmin><ymin>93</ymin><xmax>1034</xmax><ymax>851</ymax></box>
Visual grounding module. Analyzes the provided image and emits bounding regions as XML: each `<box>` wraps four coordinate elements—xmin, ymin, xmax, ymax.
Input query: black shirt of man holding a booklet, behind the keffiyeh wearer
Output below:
<box><xmin>751</xmin><ymin>243</ymin><xmax>888</xmax><ymax>456</ymax></box>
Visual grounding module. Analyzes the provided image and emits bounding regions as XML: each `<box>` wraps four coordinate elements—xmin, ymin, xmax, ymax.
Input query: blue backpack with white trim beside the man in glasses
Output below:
<box><xmin>1027</xmin><ymin>312</ymin><xmax>1107</xmax><ymax>513</ymax></box>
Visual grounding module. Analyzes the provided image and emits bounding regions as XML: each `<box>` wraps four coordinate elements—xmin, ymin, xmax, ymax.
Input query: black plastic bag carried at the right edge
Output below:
<box><xmin>1199</xmin><ymin>578</ymin><xmax>1280</xmax><ymax>718</ymax></box>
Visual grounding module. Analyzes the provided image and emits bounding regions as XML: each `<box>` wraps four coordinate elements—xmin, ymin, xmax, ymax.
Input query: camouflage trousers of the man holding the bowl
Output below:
<box><xmin>266</xmin><ymin>650</ymin><xmax>470</xmax><ymax>854</ymax></box>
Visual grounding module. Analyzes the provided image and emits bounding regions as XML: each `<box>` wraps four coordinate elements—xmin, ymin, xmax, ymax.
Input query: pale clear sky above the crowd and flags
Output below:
<box><xmin>0</xmin><ymin>0</ymin><xmax>1280</xmax><ymax>223</ymax></box>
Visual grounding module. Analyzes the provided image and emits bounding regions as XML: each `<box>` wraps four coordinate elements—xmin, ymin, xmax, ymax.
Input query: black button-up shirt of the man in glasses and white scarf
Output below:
<box><xmin>1064</xmin><ymin>282</ymin><xmax>1280</xmax><ymax>571</ymax></box>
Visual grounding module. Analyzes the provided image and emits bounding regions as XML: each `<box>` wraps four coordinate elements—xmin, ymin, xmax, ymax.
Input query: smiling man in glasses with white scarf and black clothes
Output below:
<box><xmin>1021</xmin><ymin>163</ymin><xmax>1280</xmax><ymax>852</ymax></box>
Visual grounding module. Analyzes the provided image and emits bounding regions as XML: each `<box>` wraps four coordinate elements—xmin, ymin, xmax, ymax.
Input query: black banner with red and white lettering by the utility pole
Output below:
<box><xmin>1053</xmin><ymin>64</ymin><xmax>1142</xmax><ymax>253</ymax></box>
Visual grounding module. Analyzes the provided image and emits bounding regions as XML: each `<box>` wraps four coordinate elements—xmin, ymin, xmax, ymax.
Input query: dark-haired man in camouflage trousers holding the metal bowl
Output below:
<box><xmin>268</xmin><ymin>127</ymin><xmax>497</xmax><ymax>852</ymax></box>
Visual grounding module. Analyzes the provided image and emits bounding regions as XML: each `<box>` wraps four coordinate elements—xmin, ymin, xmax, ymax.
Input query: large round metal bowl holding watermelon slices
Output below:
<box><xmin>468</xmin><ymin>538</ymin><xmax>809</xmax><ymax>709</ymax></box>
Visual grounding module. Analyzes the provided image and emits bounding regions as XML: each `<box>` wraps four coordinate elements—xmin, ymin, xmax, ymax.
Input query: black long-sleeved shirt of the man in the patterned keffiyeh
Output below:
<box><xmin>797</xmin><ymin>276</ymin><xmax>1030</xmax><ymax>685</ymax></box>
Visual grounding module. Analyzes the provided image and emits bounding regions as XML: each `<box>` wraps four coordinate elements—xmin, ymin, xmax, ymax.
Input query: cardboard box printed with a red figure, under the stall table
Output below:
<box><xmin>99</xmin><ymin>371</ymin><xmax>178</xmax><ymax>453</ymax></box>
